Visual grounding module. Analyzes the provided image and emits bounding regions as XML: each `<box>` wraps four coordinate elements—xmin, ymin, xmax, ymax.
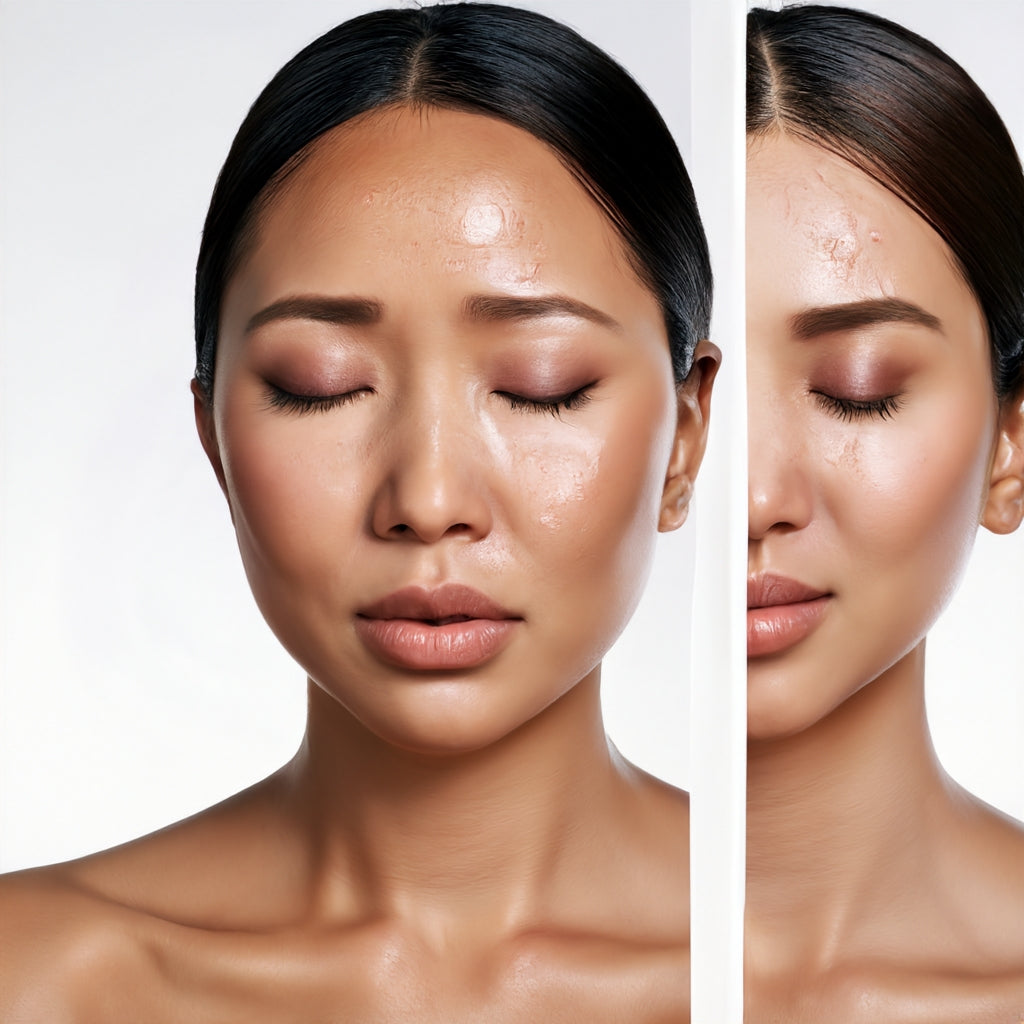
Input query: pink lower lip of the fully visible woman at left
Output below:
<box><xmin>355</xmin><ymin>618</ymin><xmax>519</xmax><ymax>672</ymax></box>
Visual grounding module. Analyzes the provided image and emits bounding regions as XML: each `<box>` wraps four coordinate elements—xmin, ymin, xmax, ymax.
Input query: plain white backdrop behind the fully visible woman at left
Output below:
<box><xmin>0</xmin><ymin>0</ymin><xmax>696</xmax><ymax>868</ymax></box>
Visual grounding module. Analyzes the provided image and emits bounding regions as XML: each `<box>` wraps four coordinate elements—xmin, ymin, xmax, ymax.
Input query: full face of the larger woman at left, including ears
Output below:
<box><xmin>198</xmin><ymin>109</ymin><xmax>707</xmax><ymax>753</ymax></box>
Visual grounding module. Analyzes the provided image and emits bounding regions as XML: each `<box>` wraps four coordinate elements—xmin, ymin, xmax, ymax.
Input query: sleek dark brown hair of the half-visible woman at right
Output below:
<box><xmin>746</xmin><ymin>6</ymin><xmax>1024</xmax><ymax>399</ymax></box>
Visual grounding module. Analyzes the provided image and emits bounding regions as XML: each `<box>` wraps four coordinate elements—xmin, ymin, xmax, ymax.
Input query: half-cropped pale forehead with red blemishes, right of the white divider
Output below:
<box><xmin>748</xmin><ymin>134</ymin><xmax>977</xmax><ymax>308</ymax></box>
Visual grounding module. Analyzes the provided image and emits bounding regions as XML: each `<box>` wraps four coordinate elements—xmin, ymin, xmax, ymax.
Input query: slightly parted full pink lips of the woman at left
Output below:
<box><xmin>355</xmin><ymin>584</ymin><xmax>522</xmax><ymax>672</ymax></box>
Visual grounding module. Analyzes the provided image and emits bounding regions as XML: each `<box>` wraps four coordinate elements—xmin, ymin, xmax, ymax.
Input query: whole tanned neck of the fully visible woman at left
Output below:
<box><xmin>276</xmin><ymin>670</ymin><xmax>627</xmax><ymax>930</ymax></box>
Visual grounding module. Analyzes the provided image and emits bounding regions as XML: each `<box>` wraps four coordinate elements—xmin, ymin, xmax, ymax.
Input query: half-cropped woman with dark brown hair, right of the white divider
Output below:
<box><xmin>746</xmin><ymin>6</ymin><xmax>1024</xmax><ymax>1022</ymax></box>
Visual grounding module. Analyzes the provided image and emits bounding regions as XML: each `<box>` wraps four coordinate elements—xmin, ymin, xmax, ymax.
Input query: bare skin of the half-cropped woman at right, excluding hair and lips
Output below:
<box><xmin>744</xmin><ymin>132</ymin><xmax>1024</xmax><ymax>1024</ymax></box>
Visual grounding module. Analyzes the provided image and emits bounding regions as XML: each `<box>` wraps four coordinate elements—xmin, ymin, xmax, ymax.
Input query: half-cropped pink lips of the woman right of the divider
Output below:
<box><xmin>746</xmin><ymin>573</ymin><xmax>833</xmax><ymax>657</ymax></box>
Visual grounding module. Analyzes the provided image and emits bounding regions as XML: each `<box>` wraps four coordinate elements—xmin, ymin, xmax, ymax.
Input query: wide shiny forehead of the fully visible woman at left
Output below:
<box><xmin>235</xmin><ymin>106</ymin><xmax>632</xmax><ymax>296</ymax></box>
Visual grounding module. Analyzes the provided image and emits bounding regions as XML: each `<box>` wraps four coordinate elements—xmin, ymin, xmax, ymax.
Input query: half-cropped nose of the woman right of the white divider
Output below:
<box><xmin>746</xmin><ymin>382</ymin><xmax>813</xmax><ymax>541</ymax></box>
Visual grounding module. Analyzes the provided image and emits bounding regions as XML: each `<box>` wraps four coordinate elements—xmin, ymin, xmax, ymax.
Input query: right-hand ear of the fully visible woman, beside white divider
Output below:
<box><xmin>657</xmin><ymin>341</ymin><xmax>722</xmax><ymax>534</ymax></box>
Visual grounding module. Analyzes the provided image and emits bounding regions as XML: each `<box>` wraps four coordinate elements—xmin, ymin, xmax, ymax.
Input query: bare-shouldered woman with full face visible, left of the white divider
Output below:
<box><xmin>4</xmin><ymin>4</ymin><xmax>717</xmax><ymax>1021</ymax></box>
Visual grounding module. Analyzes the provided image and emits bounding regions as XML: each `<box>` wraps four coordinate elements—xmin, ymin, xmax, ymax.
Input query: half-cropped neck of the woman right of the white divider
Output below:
<box><xmin>746</xmin><ymin>643</ymin><xmax>953</xmax><ymax>962</ymax></box>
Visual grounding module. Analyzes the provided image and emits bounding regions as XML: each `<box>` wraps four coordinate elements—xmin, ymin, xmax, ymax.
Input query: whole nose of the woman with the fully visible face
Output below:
<box><xmin>372</xmin><ymin>394</ymin><xmax>493</xmax><ymax>544</ymax></box>
